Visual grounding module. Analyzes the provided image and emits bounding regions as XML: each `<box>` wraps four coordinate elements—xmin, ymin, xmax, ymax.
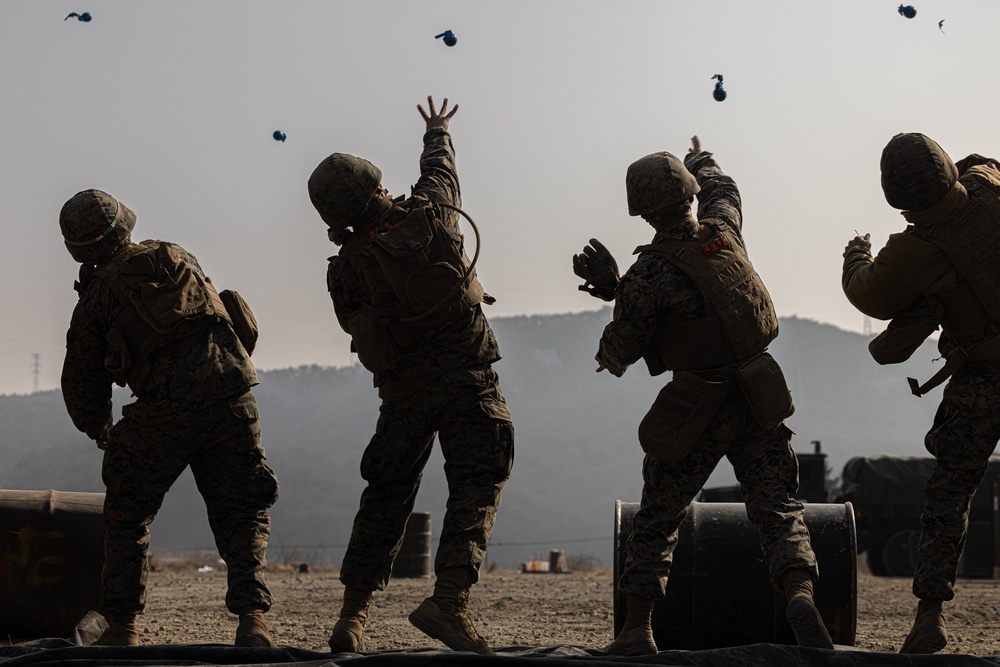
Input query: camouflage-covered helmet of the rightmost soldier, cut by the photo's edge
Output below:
<box><xmin>881</xmin><ymin>132</ymin><xmax>958</xmax><ymax>211</ymax></box>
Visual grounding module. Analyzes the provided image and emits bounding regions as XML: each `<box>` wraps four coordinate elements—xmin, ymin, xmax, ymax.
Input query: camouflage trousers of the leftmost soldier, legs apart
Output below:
<box><xmin>101</xmin><ymin>391</ymin><xmax>278</xmax><ymax>617</ymax></box>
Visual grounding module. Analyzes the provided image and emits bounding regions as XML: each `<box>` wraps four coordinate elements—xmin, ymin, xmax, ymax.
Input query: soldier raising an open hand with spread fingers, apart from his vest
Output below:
<box><xmin>309</xmin><ymin>98</ymin><xmax>514</xmax><ymax>654</ymax></box>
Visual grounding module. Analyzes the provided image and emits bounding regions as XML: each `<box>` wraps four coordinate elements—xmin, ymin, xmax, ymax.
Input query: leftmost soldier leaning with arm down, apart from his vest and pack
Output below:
<box><xmin>59</xmin><ymin>190</ymin><xmax>278</xmax><ymax>646</ymax></box>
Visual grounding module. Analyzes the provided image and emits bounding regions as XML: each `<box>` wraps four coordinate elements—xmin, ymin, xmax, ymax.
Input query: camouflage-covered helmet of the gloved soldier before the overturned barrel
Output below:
<box><xmin>625</xmin><ymin>151</ymin><xmax>701</xmax><ymax>215</ymax></box>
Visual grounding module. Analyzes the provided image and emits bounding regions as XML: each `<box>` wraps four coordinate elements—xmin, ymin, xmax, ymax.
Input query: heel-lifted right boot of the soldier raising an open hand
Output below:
<box><xmin>410</xmin><ymin>568</ymin><xmax>494</xmax><ymax>655</ymax></box>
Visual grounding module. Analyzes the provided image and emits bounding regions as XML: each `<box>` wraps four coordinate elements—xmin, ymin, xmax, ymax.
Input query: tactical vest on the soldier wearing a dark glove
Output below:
<box><xmin>635</xmin><ymin>223</ymin><xmax>778</xmax><ymax>371</ymax></box>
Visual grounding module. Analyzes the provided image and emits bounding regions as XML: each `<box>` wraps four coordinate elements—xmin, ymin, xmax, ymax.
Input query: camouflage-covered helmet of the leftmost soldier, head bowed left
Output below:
<box><xmin>59</xmin><ymin>190</ymin><xmax>135</xmax><ymax>264</ymax></box>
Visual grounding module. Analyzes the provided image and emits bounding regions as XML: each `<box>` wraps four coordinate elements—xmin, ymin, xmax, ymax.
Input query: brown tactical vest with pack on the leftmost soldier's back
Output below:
<box><xmin>92</xmin><ymin>241</ymin><xmax>230</xmax><ymax>396</ymax></box>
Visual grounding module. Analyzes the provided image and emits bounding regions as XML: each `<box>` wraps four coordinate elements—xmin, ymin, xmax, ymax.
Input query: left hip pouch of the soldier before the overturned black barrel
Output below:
<box><xmin>639</xmin><ymin>371</ymin><xmax>729</xmax><ymax>463</ymax></box>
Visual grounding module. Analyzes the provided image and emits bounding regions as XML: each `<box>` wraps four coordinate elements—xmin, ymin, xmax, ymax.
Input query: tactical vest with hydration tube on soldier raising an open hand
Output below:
<box><xmin>340</xmin><ymin>199</ymin><xmax>485</xmax><ymax>347</ymax></box>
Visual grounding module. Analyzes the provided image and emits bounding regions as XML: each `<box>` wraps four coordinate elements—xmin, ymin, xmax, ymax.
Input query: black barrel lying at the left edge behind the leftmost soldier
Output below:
<box><xmin>0</xmin><ymin>489</ymin><xmax>104</xmax><ymax>639</ymax></box>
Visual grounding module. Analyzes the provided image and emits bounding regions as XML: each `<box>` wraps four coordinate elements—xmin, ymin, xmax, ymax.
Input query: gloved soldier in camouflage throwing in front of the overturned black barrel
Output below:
<box><xmin>574</xmin><ymin>137</ymin><xmax>833</xmax><ymax>655</ymax></box>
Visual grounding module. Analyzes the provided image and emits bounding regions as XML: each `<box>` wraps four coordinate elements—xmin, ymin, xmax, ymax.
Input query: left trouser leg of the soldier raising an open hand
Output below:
<box><xmin>340</xmin><ymin>395</ymin><xmax>435</xmax><ymax>591</ymax></box>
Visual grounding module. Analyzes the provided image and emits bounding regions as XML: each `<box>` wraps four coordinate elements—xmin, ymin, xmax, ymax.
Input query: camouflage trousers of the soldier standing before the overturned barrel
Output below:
<box><xmin>618</xmin><ymin>397</ymin><xmax>819</xmax><ymax>600</ymax></box>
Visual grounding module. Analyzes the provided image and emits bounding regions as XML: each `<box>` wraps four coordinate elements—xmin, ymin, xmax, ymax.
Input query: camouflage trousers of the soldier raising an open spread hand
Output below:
<box><xmin>340</xmin><ymin>369</ymin><xmax>514</xmax><ymax>590</ymax></box>
